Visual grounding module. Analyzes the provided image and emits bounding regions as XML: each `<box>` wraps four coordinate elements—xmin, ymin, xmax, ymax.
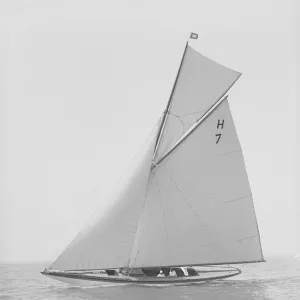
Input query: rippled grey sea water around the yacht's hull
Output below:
<box><xmin>0</xmin><ymin>257</ymin><xmax>300</xmax><ymax>300</ymax></box>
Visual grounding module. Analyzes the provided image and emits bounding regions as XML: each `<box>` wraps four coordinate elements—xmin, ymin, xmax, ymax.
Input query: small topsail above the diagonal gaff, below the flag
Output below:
<box><xmin>155</xmin><ymin>45</ymin><xmax>241</xmax><ymax>162</ymax></box>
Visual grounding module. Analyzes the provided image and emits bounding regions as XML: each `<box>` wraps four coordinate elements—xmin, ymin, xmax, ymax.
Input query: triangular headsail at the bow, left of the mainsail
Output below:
<box><xmin>50</xmin><ymin>131</ymin><xmax>156</xmax><ymax>270</ymax></box>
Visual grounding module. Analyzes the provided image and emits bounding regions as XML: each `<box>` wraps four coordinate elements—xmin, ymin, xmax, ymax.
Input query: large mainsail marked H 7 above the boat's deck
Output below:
<box><xmin>130</xmin><ymin>100</ymin><xmax>263</xmax><ymax>267</ymax></box>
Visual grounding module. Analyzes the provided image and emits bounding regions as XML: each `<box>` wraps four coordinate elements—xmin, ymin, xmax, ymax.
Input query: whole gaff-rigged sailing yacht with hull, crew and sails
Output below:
<box><xmin>41</xmin><ymin>33</ymin><xmax>264</xmax><ymax>285</ymax></box>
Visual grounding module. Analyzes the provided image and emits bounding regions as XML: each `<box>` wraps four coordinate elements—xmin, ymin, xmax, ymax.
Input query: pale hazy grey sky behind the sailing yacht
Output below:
<box><xmin>0</xmin><ymin>0</ymin><xmax>300</xmax><ymax>262</ymax></box>
